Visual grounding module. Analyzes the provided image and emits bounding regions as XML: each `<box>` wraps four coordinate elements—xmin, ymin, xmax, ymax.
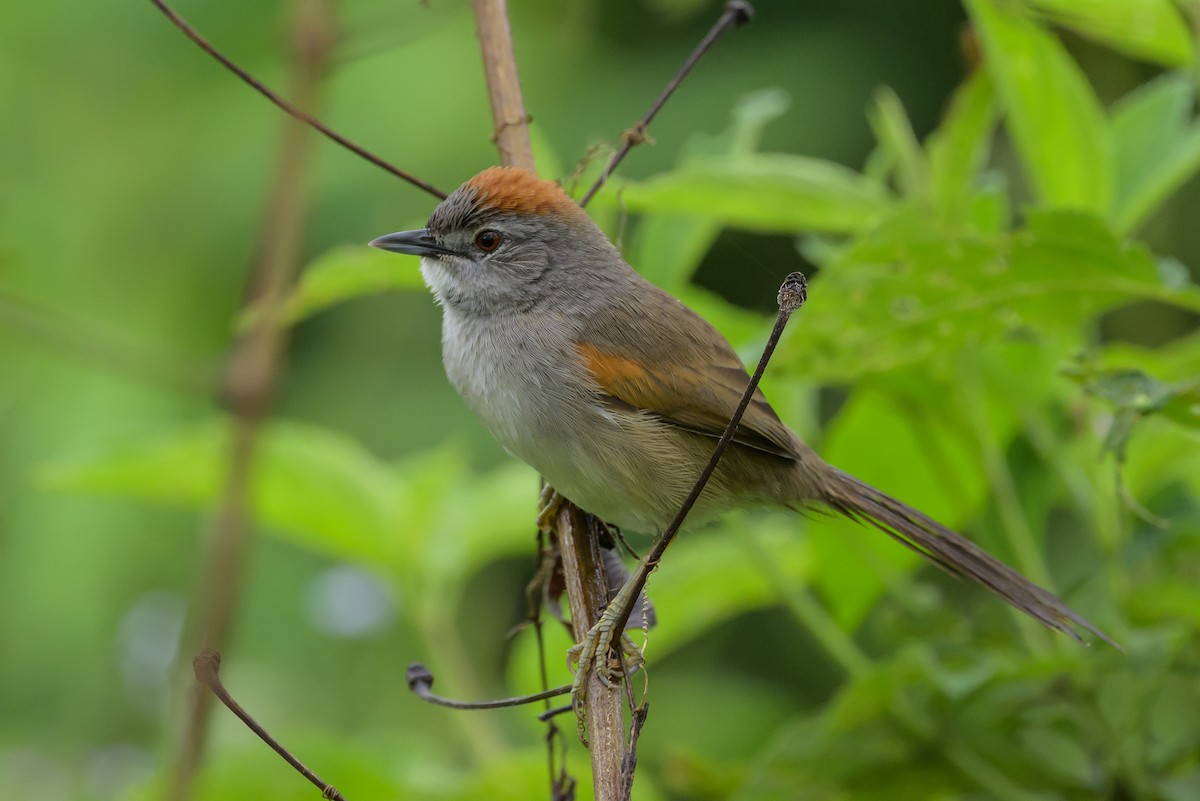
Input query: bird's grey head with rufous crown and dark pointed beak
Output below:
<box><xmin>371</xmin><ymin>167</ymin><xmax>632</xmax><ymax>314</ymax></box>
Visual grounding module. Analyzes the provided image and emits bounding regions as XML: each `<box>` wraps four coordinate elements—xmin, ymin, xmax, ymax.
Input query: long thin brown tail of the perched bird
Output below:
<box><xmin>823</xmin><ymin>468</ymin><xmax>1121</xmax><ymax>649</ymax></box>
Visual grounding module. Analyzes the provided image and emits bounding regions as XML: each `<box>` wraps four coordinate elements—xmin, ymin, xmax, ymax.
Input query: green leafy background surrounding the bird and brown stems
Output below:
<box><xmin>0</xmin><ymin>0</ymin><xmax>1200</xmax><ymax>801</ymax></box>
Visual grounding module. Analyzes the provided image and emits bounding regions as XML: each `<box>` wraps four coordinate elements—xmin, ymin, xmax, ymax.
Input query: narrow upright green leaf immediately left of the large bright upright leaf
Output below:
<box><xmin>925</xmin><ymin>70</ymin><xmax>997</xmax><ymax>222</ymax></box>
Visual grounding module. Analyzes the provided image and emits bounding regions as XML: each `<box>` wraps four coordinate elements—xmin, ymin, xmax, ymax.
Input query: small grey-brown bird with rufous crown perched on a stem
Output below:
<box><xmin>370</xmin><ymin>167</ymin><xmax>1120</xmax><ymax>648</ymax></box>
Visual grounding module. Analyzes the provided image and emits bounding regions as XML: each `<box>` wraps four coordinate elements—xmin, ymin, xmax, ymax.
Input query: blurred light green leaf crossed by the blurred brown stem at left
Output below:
<box><xmin>42</xmin><ymin>420</ymin><xmax>403</xmax><ymax>562</ymax></box>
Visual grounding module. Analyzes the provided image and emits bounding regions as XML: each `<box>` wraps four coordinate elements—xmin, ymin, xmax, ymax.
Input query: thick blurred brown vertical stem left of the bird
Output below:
<box><xmin>167</xmin><ymin>0</ymin><xmax>335</xmax><ymax>801</ymax></box>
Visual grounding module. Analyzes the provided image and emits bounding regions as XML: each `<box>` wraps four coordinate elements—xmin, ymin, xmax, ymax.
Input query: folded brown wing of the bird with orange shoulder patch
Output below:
<box><xmin>576</xmin><ymin>293</ymin><xmax>799</xmax><ymax>459</ymax></box>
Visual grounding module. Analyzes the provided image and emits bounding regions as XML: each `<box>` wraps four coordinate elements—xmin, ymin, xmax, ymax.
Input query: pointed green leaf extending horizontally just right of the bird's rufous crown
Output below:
<box><xmin>622</xmin><ymin>153</ymin><xmax>890</xmax><ymax>233</ymax></box>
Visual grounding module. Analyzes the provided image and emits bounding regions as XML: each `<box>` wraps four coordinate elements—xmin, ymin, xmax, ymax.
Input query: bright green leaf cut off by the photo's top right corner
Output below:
<box><xmin>1026</xmin><ymin>0</ymin><xmax>1195</xmax><ymax>67</ymax></box>
